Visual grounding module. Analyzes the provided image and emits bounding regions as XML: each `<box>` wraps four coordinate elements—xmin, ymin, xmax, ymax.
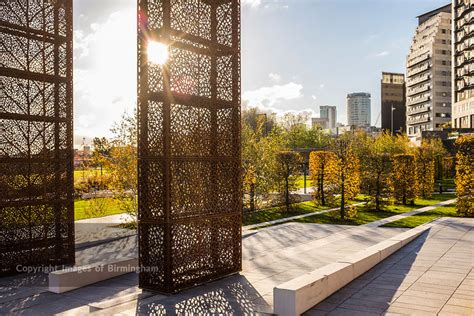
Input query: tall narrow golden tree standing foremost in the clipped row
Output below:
<box><xmin>334</xmin><ymin>134</ymin><xmax>360</xmax><ymax>221</ymax></box>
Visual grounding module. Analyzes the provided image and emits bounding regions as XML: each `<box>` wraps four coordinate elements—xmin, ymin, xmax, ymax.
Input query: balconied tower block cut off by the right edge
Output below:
<box><xmin>452</xmin><ymin>0</ymin><xmax>474</xmax><ymax>128</ymax></box>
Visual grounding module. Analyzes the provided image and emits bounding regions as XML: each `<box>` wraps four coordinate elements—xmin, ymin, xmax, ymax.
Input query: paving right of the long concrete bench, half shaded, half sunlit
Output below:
<box><xmin>306</xmin><ymin>218</ymin><xmax>474</xmax><ymax>316</ymax></box>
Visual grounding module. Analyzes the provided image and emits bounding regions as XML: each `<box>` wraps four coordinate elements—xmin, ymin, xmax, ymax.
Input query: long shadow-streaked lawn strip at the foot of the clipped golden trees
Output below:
<box><xmin>296</xmin><ymin>194</ymin><xmax>454</xmax><ymax>225</ymax></box>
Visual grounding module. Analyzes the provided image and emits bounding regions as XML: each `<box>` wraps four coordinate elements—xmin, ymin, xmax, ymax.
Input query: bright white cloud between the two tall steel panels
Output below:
<box><xmin>74</xmin><ymin>8</ymin><xmax>137</xmax><ymax>142</ymax></box>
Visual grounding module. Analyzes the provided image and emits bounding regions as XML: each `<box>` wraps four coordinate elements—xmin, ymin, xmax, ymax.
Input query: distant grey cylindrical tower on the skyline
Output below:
<box><xmin>347</xmin><ymin>92</ymin><xmax>370</xmax><ymax>127</ymax></box>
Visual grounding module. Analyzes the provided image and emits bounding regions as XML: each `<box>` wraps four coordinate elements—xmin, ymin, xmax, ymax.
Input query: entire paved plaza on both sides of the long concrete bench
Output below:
<box><xmin>0</xmin><ymin>219</ymin><xmax>474</xmax><ymax>315</ymax></box>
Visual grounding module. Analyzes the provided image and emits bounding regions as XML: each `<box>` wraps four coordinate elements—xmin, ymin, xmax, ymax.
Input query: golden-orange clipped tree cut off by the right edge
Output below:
<box><xmin>455</xmin><ymin>136</ymin><xmax>474</xmax><ymax>217</ymax></box>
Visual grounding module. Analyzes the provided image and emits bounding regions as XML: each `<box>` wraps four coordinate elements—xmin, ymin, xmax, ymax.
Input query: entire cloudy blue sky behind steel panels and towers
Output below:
<box><xmin>74</xmin><ymin>0</ymin><xmax>449</xmax><ymax>144</ymax></box>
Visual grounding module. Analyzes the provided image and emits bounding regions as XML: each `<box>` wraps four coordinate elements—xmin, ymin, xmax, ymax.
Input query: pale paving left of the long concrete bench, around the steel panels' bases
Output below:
<box><xmin>0</xmin><ymin>223</ymin><xmax>405</xmax><ymax>316</ymax></box>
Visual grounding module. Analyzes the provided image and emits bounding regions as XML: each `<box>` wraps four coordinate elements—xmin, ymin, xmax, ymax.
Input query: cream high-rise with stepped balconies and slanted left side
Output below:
<box><xmin>406</xmin><ymin>4</ymin><xmax>451</xmax><ymax>141</ymax></box>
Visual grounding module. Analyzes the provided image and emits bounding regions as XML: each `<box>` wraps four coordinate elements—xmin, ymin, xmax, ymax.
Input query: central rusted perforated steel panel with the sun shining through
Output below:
<box><xmin>138</xmin><ymin>0</ymin><xmax>242</xmax><ymax>293</ymax></box>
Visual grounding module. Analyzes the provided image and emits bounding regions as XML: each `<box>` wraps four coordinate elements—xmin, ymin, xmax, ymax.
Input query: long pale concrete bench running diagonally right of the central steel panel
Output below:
<box><xmin>273</xmin><ymin>226</ymin><xmax>429</xmax><ymax>316</ymax></box>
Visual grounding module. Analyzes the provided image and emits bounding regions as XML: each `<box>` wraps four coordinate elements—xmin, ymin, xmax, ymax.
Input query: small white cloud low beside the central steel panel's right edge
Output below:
<box><xmin>242</xmin><ymin>82</ymin><xmax>303</xmax><ymax>108</ymax></box>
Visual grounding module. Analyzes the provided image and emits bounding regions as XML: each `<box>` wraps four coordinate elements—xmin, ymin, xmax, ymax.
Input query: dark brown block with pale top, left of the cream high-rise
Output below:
<box><xmin>381</xmin><ymin>72</ymin><xmax>406</xmax><ymax>133</ymax></box>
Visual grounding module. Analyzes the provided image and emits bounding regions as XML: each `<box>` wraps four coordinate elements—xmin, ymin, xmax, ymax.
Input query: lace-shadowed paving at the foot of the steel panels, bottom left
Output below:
<box><xmin>0</xmin><ymin>273</ymin><xmax>271</xmax><ymax>315</ymax></box>
